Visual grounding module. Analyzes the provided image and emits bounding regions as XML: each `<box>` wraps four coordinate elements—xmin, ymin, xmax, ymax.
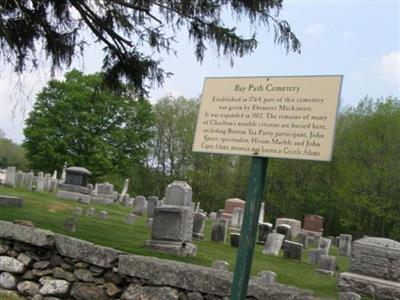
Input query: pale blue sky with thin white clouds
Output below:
<box><xmin>0</xmin><ymin>0</ymin><xmax>400</xmax><ymax>143</ymax></box>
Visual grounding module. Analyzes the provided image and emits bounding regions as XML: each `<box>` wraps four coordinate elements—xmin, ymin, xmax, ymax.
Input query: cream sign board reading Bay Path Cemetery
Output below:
<box><xmin>193</xmin><ymin>75</ymin><xmax>343</xmax><ymax>161</ymax></box>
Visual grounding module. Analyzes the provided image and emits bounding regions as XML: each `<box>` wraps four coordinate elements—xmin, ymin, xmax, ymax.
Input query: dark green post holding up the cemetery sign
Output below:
<box><xmin>231</xmin><ymin>157</ymin><xmax>268</xmax><ymax>300</ymax></box>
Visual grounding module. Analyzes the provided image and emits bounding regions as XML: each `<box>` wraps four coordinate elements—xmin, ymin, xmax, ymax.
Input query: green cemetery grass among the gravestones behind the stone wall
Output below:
<box><xmin>0</xmin><ymin>187</ymin><xmax>348</xmax><ymax>299</ymax></box>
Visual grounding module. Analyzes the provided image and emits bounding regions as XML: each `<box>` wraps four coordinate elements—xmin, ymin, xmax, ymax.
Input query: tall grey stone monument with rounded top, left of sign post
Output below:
<box><xmin>146</xmin><ymin>181</ymin><xmax>197</xmax><ymax>256</ymax></box>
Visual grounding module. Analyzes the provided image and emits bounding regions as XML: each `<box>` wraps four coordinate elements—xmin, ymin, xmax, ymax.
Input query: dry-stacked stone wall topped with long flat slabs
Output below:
<box><xmin>0</xmin><ymin>221</ymin><xmax>315</xmax><ymax>300</ymax></box>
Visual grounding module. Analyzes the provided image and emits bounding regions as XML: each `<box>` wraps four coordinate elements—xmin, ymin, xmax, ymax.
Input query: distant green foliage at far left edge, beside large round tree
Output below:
<box><xmin>0</xmin><ymin>129</ymin><xmax>28</xmax><ymax>170</ymax></box>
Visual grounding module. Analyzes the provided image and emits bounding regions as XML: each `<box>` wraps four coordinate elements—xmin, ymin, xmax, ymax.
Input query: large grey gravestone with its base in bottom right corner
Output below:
<box><xmin>338</xmin><ymin>237</ymin><xmax>400</xmax><ymax>299</ymax></box>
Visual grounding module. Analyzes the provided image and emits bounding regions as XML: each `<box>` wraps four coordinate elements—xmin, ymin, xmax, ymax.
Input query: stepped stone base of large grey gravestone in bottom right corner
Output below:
<box><xmin>338</xmin><ymin>272</ymin><xmax>400</xmax><ymax>299</ymax></box>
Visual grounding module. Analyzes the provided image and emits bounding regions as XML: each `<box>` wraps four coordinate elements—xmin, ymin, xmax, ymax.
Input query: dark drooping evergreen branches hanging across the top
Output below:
<box><xmin>0</xmin><ymin>0</ymin><xmax>300</xmax><ymax>91</ymax></box>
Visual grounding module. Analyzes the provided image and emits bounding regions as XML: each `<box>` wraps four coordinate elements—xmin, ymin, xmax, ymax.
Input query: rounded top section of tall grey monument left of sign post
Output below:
<box><xmin>164</xmin><ymin>180</ymin><xmax>192</xmax><ymax>207</ymax></box>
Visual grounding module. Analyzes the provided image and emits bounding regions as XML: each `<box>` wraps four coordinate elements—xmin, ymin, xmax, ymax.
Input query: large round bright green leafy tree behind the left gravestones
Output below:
<box><xmin>24</xmin><ymin>70</ymin><xmax>152</xmax><ymax>176</ymax></box>
